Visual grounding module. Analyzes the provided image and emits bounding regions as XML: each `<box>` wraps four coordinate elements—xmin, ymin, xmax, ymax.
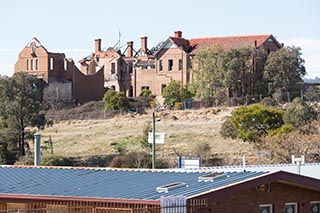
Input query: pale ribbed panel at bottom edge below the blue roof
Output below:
<box><xmin>160</xmin><ymin>195</ymin><xmax>187</xmax><ymax>213</ymax></box>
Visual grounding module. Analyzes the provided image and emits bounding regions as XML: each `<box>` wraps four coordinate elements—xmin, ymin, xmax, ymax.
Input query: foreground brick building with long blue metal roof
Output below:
<box><xmin>0</xmin><ymin>166</ymin><xmax>320</xmax><ymax>213</ymax></box>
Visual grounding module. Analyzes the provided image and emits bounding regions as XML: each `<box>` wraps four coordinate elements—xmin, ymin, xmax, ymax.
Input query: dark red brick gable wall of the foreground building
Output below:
<box><xmin>201</xmin><ymin>182</ymin><xmax>320</xmax><ymax>213</ymax></box>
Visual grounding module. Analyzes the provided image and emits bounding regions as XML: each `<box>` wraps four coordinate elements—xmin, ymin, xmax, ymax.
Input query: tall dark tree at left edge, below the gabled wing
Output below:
<box><xmin>0</xmin><ymin>72</ymin><xmax>45</xmax><ymax>155</ymax></box>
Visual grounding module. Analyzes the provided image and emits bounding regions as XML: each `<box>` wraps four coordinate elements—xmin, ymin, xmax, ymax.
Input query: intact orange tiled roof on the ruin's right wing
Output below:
<box><xmin>189</xmin><ymin>34</ymin><xmax>272</xmax><ymax>53</ymax></box>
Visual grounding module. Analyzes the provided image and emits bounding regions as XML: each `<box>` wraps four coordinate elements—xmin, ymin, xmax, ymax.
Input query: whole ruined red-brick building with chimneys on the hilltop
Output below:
<box><xmin>15</xmin><ymin>31</ymin><xmax>283</xmax><ymax>103</ymax></box>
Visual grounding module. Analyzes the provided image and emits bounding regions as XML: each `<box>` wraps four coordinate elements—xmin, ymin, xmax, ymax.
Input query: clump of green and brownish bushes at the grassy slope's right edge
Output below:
<box><xmin>220</xmin><ymin>98</ymin><xmax>320</xmax><ymax>163</ymax></box>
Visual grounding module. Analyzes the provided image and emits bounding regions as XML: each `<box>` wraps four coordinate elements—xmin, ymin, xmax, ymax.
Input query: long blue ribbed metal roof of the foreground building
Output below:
<box><xmin>0</xmin><ymin>166</ymin><xmax>265</xmax><ymax>200</ymax></box>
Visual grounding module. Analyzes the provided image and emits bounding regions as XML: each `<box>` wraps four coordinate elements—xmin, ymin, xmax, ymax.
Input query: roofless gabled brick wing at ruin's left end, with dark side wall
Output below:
<box><xmin>14</xmin><ymin>38</ymin><xmax>106</xmax><ymax>104</ymax></box>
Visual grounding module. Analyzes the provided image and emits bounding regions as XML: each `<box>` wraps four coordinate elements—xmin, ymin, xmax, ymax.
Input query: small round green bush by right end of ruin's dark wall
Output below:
<box><xmin>103</xmin><ymin>90</ymin><xmax>129</xmax><ymax>110</ymax></box>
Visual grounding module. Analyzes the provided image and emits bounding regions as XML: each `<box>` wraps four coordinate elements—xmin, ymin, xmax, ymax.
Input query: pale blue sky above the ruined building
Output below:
<box><xmin>0</xmin><ymin>0</ymin><xmax>320</xmax><ymax>78</ymax></box>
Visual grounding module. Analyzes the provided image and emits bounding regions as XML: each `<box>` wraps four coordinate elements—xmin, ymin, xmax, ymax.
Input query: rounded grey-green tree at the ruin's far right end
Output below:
<box><xmin>264</xmin><ymin>46</ymin><xmax>306</xmax><ymax>92</ymax></box>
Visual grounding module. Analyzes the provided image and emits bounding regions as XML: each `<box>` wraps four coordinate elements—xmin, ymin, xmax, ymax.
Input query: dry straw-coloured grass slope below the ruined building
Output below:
<box><xmin>41</xmin><ymin>108</ymin><xmax>255</xmax><ymax>165</ymax></box>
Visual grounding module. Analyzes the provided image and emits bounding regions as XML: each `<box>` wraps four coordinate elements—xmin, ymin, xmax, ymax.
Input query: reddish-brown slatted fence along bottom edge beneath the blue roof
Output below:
<box><xmin>0</xmin><ymin>199</ymin><xmax>209</xmax><ymax>213</ymax></box>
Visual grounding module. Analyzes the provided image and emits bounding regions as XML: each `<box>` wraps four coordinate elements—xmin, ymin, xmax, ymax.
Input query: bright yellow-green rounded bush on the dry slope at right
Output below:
<box><xmin>226</xmin><ymin>104</ymin><xmax>283</xmax><ymax>142</ymax></box>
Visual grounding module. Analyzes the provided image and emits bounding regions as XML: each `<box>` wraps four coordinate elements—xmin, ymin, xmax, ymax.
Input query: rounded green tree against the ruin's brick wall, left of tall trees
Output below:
<box><xmin>162</xmin><ymin>81</ymin><xmax>192</xmax><ymax>106</ymax></box>
